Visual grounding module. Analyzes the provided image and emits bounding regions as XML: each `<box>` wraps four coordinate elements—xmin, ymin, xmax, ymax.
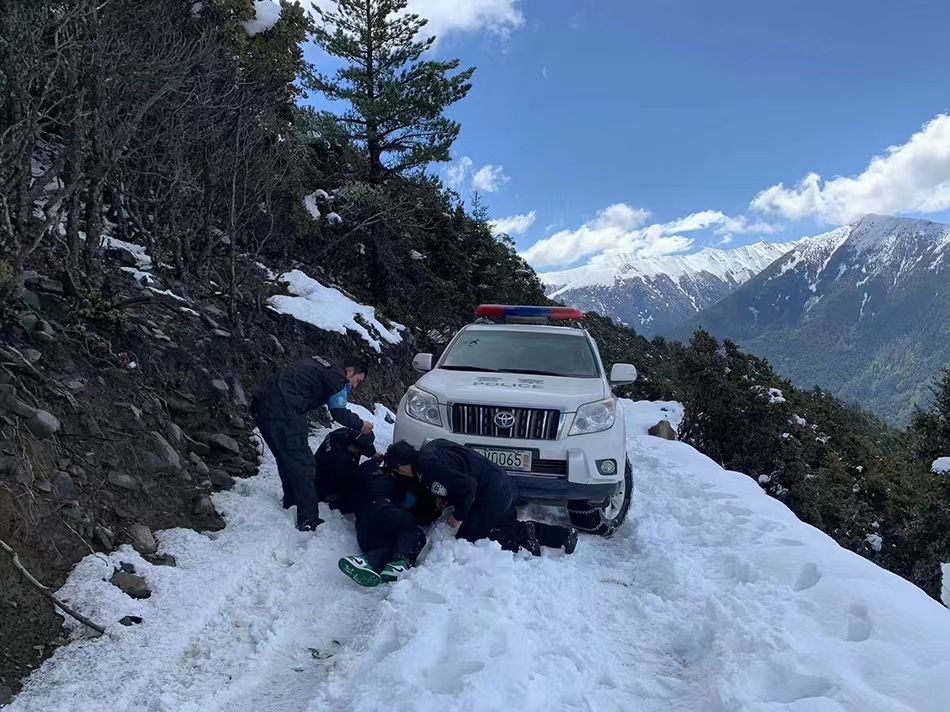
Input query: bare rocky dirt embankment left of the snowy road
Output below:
<box><xmin>0</xmin><ymin>255</ymin><xmax>412</xmax><ymax>704</ymax></box>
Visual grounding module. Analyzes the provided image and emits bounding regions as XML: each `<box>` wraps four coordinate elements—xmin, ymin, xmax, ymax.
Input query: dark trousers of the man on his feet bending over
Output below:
<box><xmin>254</xmin><ymin>413</ymin><xmax>320</xmax><ymax>527</ymax></box>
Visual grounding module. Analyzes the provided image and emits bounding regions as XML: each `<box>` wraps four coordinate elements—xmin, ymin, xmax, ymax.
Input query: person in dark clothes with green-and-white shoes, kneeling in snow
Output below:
<box><xmin>339</xmin><ymin>460</ymin><xmax>426</xmax><ymax>586</ymax></box>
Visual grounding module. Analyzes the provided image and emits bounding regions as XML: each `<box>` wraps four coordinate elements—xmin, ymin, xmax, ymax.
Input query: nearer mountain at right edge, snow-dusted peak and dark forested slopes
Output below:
<box><xmin>675</xmin><ymin>215</ymin><xmax>950</xmax><ymax>422</ymax></box>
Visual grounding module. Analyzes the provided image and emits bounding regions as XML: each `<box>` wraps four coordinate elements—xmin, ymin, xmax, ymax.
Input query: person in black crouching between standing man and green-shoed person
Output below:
<box><xmin>313</xmin><ymin>428</ymin><xmax>376</xmax><ymax>514</ymax></box>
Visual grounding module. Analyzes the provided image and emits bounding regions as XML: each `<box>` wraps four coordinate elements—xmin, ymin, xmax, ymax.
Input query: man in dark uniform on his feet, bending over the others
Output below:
<box><xmin>251</xmin><ymin>356</ymin><xmax>373</xmax><ymax>531</ymax></box>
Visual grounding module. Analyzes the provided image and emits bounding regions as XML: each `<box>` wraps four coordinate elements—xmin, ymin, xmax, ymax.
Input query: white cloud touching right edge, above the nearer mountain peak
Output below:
<box><xmin>752</xmin><ymin>114</ymin><xmax>950</xmax><ymax>224</ymax></box>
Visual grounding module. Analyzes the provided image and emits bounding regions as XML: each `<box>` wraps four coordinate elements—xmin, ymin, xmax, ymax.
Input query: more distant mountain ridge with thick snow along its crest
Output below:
<box><xmin>541</xmin><ymin>242</ymin><xmax>797</xmax><ymax>336</ymax></box>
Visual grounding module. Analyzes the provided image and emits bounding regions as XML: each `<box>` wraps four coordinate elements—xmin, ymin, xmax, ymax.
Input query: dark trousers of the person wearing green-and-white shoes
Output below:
<box><xmin>356</xmin><ymin>505</ymin><xmax>426</xmax><ymax>572</ymax></box>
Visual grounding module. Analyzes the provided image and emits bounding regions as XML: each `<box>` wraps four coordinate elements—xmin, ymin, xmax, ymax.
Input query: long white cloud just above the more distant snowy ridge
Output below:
<box><xmin>523</xmin><ymin>203</ymin><xmax>779</xmax><ymax>269</ymax></box>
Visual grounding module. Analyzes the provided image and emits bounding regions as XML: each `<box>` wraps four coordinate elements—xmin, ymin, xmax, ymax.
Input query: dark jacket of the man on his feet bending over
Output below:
<box><xmin>254</xmin><ymin>357</ymin><xmax>363</xmax><ymax>429</ymax></box>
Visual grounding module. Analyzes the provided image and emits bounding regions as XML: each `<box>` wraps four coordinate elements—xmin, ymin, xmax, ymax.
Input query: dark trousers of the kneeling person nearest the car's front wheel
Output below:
<box><xmin>456</xmin><ymin>488</ymin><xmax>570</xmax><ymax>552</ymax></box>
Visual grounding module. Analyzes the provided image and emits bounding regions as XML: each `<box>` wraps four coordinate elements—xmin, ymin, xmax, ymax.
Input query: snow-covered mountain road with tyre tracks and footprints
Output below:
<box><xmin>11</xmin><ymin>403</ymin><xmax>950</xmax><ymax>712</ymax></box>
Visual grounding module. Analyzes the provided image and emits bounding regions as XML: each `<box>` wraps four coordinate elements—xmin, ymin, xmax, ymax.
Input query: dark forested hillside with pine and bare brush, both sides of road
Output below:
<box><xmin>0</xmin><ymin>0</ymin><xmax>950</xmax><ymax>700</ymax></box>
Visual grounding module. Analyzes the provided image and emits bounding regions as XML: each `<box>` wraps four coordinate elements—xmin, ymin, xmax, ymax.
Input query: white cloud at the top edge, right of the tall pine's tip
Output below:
<box><xmin>304</xmin><ymin>0</ymin><xmax>524</xmax><ymax>37</ymax></box>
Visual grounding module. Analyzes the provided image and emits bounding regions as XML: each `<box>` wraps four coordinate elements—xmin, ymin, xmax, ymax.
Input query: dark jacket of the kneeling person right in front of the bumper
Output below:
<box><xmin>413</xmin><ymin>440</ymin><xmax>512</xmax><ymax>521</ymax></box>
